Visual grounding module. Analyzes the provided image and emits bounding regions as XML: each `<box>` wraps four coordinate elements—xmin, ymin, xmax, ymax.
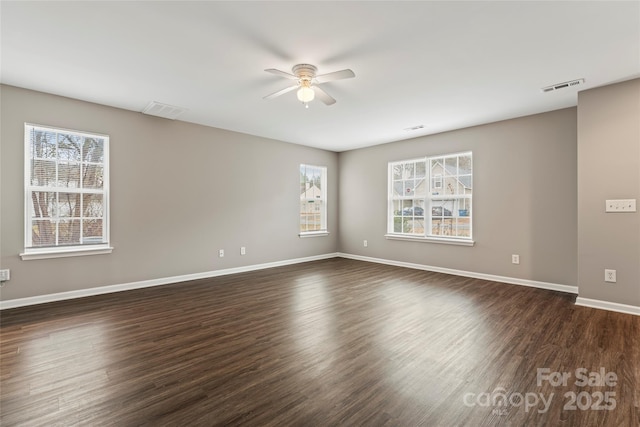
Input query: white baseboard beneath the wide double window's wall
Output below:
<box><xmin>338</xmin><ymin>253</ymin><xmax>578</xmax><ymax>294</ymax></box>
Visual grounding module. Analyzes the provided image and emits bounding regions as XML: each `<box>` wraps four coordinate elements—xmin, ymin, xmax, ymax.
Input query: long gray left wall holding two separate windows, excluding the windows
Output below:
<box><xmin>0</xmin><ymin>86</ymin><xmax>338</xmax><ymax>300</ymax></box>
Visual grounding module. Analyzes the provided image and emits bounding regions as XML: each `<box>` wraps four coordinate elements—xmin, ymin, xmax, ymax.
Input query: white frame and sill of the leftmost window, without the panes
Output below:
<box><xmin>20</xmin><ymin>123</ymin><xmax>113</xmax><ymax>260</ymax></box>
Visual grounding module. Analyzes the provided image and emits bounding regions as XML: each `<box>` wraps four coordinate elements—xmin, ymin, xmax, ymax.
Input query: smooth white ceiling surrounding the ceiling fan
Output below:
<box><xmin>0</xmin><ymin>1</ymin><xmax>640</xmax><ymax>151</ymax></box>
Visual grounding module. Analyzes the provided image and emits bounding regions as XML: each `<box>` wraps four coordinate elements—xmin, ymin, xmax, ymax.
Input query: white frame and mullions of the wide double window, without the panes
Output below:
<box><xmin>385</xmin><ymin>151</ymin><xmax>475</xmax><ymax>246</ymax></box>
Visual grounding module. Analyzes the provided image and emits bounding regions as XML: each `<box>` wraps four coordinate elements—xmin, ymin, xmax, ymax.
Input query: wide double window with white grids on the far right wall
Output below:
<box><xmin>387</xmin><ymin>152</ymin><xmax>473</xmax><ymax>244</ymax></box>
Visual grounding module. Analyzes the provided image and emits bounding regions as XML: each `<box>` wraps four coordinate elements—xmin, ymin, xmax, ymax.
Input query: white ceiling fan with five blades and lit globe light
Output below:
<box><xmin>264</xmin><ymin>64</ymin><xmax>356</xmax><ymax>108</ymax></box>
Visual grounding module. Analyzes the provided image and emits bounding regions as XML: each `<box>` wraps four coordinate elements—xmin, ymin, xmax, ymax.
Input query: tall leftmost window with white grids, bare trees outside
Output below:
<box><xmin>22</xmin><ymin>124</ymin><xmax>111</xmax><ymax>259</ymax></box>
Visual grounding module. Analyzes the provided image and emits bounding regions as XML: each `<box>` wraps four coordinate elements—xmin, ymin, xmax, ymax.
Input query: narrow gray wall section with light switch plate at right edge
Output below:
<box><xmin>578</xmin><ymin>79</ymin><xmax>640</xmax><ymax>306</ymax></box>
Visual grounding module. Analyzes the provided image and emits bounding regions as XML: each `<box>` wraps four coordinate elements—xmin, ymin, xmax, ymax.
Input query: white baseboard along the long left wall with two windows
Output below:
<box><xmin>0</xmin><ymin>253</ymin><xmax>338</xmax><ymax>310</ymax></box>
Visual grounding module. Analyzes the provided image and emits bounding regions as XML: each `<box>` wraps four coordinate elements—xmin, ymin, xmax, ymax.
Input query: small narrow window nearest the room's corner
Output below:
<box><xmin>300</xmin><ymin>165</ymin><xmax>328</xmax><ymax>237</ymax></box>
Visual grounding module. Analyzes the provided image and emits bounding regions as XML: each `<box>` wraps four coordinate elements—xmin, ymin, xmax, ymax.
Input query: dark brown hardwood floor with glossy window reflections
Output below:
<box><xmin>0</xmin><ymin>258</ymin><xmax>640</xmax><ymax>426</ymax></box>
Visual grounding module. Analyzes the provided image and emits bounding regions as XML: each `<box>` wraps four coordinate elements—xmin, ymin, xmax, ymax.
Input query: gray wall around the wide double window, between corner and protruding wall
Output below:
<box><xmin>338</xmin><ymin>108</ymin><xmax>577</xmax><ymax>286</ymax></box>
